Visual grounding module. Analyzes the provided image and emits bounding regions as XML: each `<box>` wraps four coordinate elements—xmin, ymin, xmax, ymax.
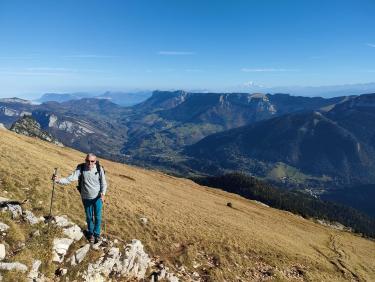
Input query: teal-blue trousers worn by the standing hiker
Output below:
<box><xmin>82</xmin><ymin>197</ymin><xmax>103</xmax><ymax>237</ymax></box>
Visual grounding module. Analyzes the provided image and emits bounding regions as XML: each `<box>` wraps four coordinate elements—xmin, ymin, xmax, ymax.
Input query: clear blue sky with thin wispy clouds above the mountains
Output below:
<box><xmin>0</xmin><ymin>0</ymin><xmax>375</xmax><ymax>97</ymax></box>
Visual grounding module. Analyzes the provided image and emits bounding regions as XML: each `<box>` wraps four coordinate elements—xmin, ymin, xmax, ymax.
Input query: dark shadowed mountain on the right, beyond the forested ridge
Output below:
<box><xmin>185</xmin><ymin>95</ymin><xmax>375</xmax><ymax>187</ymax></box>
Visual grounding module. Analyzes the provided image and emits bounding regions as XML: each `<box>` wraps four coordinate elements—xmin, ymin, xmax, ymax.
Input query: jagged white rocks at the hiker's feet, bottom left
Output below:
<box><xmin>0</xmin><ymin>198</ymin><xmax>201</xmax><ymax>282</ymax></box>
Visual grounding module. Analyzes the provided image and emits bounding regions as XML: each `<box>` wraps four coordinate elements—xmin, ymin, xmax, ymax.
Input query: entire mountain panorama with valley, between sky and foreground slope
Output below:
<box><xmin>0</xmin><ymin>91</ymin><xmax>375</xmax><ymax>216</ymax></box>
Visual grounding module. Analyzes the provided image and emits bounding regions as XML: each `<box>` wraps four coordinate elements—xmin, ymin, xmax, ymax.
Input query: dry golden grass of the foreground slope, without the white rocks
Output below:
<box><xmin>0</xmin><ymin>131</ymin><xmax>375</xmax><ymax>281</ymax></box>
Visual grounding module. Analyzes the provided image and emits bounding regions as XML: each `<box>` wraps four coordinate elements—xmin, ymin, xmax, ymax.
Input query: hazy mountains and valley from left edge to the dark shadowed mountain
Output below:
<box><xmin>0</xmin><ymin>91</ymin><xmax>362</xmax><ymax>171</ymax></box>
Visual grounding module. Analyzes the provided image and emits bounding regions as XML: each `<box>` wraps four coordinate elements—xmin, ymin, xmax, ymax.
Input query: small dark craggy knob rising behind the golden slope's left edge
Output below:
<box><xmin>10</xmin><ymin>115</ymin><xmax>63</xmax><ymax>146</ymax></box>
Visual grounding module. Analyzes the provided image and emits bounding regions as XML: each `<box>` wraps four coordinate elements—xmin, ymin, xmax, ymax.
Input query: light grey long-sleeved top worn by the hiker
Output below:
<box><xmin>57</xmin><ymin>166</ymin><xmax>107</xmax><ymax>199</ymax></box>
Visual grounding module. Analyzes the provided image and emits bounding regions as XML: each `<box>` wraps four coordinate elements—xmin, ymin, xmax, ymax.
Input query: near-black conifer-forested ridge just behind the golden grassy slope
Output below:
<box><xmin>193</xmin><ymin>173</ymin><xmax>375</xmax><ymax>238</ymax></box>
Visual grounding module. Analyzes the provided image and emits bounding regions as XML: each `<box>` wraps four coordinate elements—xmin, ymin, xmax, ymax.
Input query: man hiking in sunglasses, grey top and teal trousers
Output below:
<box><xmin>52</xmin><ymin>153</ymin><xmax>107</xmax><ymax>243</ymax></box>
